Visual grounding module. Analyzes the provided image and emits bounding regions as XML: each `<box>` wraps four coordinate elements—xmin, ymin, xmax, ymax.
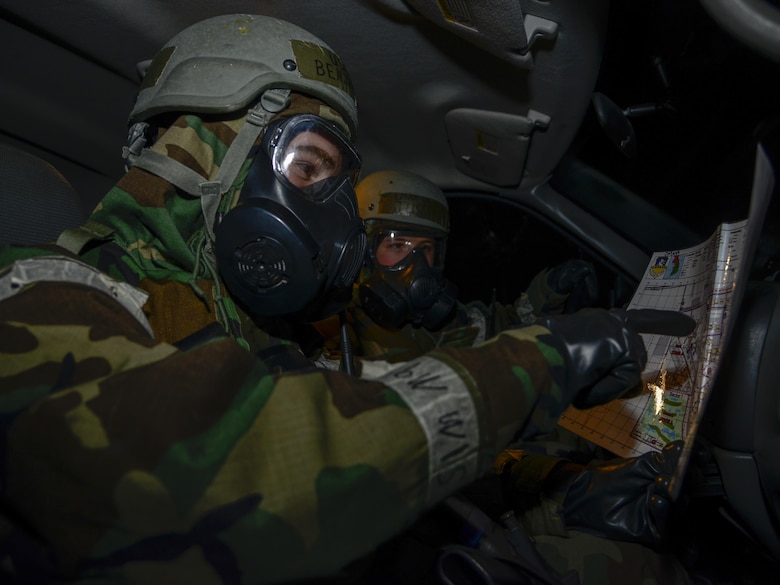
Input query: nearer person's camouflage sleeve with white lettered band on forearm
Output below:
<box><xmin>0</xmin><ymin>266</ymin><xmax>565</xmax><ymax>583</ymax></box>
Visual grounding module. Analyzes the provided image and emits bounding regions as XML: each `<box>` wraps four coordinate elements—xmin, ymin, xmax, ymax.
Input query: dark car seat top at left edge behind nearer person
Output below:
<box><xmin>0</xmin><ymin>143</ymin><xmax>86</xmax><ymax>245</ymax></box>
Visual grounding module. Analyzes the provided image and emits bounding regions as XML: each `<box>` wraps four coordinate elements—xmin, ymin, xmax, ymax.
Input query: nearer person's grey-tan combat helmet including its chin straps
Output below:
<box><xmin>123</xmin><ymin>14</ymin><xmax>357</xmax><ymax>248</ymax></box>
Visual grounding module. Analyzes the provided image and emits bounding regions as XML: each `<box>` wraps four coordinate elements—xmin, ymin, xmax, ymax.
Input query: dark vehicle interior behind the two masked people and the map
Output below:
<box><xmin>0</xmin><ymin>0</ymin><xmax>780</xmax><ymax>585</ymax></box>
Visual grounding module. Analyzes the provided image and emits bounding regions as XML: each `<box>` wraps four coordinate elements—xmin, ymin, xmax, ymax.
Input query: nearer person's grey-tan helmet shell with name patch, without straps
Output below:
<box><xmin>130</xmin><ymin>14</ymin><xmax>357</xmax><ymax>140</ymax></box>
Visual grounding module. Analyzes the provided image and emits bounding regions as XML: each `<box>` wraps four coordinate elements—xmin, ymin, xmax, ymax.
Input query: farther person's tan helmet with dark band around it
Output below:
<box><xmin>355</xmin><ymin>171</ymin><xmax>450</xmax><ymax>234</ymax></box>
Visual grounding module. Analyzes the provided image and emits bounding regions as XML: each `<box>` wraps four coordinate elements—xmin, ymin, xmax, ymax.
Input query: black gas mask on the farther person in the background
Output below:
<box><xmin>358</xmin><ymin>229</ymin><xmax>457</xmax><ymax>330</ymax></box>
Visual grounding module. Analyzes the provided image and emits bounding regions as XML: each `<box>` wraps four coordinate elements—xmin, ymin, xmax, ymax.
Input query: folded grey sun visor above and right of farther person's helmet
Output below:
<box><xmin>445</xmin><ymin>108</ymin><xmax>550</xmax><ymax>187</ymax></box>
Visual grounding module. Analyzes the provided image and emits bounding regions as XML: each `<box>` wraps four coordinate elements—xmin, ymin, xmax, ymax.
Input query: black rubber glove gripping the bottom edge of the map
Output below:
<box><xmin>545</xmin><ymin>441</ymin><xmax>683</xmax><ymax>547</ymax></box>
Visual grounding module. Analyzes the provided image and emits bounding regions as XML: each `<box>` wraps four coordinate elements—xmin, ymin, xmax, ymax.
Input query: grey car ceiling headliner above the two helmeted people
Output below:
<box><xmin>0</xmin><ymin>0</ymin><xmax>608</xmax><ymax>208</ymax></box>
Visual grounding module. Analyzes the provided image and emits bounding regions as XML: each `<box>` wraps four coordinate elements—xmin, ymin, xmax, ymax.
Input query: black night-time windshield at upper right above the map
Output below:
<box><xmin>551</xmin><ymin>2</ymin><xmax>780</xmax><ymax>282</ymax></box>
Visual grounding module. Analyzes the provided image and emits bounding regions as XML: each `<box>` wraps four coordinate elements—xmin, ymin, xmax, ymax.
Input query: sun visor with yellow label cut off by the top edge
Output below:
<box><xmin>406</xmin><ymin>0</ymin><xmax>558</xmax><ymax>69</ymax></box>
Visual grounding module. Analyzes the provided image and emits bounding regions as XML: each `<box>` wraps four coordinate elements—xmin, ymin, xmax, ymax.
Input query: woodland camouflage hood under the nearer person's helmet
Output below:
<box><xmin>83</xmin><ymin>94</ymin><xmax>346</xmax><ymax>342</ymax></box>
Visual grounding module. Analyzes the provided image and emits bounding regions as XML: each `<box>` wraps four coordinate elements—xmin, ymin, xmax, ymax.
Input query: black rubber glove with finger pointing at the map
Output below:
<box><xmin>536</xmin><ymin>309</ymin><xmax>696</xmax><ymax>408</ymax></box>
